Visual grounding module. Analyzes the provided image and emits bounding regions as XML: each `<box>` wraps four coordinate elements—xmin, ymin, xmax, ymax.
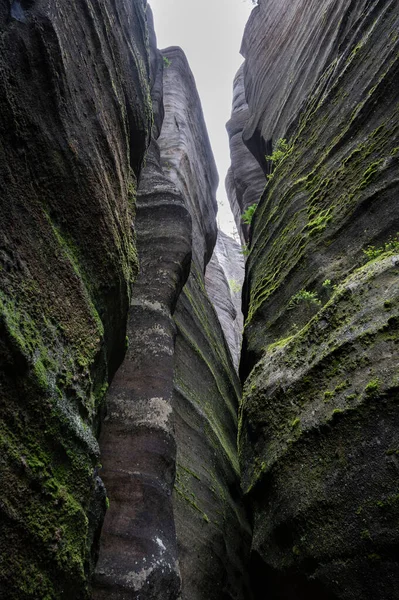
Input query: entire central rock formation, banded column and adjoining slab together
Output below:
<box><xmin>94</xmin><ymin>43</ymin><xmax>249</xmax><ymax>600</ymax></box>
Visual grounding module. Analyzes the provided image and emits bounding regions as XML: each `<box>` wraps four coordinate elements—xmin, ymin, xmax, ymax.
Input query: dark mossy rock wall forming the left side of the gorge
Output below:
<box><xmin>0</xmin><ymin>0</ymin><xmax>152</xmax><ymax>600</ymax></box>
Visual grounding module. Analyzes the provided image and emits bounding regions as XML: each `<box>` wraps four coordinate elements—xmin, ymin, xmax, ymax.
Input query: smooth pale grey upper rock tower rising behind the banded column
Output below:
<box><xmin>159</xmin><ymin>47</ymin><xmax>219</xmax><ymax>271</ymax></box>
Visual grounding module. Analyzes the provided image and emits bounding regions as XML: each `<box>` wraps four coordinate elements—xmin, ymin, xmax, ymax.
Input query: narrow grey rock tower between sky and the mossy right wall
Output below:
<box><xmin>226</xmin><ymin>65</ymin><xmax>266</xmax><ymax>244</ymax></box>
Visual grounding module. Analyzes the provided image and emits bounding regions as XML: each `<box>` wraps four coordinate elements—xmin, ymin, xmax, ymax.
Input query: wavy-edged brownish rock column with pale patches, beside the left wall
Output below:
<box><xmin>94</xmin><ymin>29</ymin><xmax>191</xmax><ymax>600</ymax></box>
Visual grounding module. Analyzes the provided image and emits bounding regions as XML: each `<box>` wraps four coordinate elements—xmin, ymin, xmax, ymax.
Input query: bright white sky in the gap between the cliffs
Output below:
<box><xmin>149</xmin><ymin>0</ymin><xmax>253</xmax><ymax>235</ymax></box>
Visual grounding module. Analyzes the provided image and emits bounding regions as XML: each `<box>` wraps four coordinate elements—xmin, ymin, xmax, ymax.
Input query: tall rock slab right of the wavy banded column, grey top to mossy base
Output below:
<box><xmin>159</xmin><ymin>48</ymin><xmax>250</xmax><ymax>600</ymax></box>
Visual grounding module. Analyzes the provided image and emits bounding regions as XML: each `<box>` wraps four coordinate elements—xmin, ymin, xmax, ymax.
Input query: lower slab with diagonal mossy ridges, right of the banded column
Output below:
<box><xmin>174</xmin><ymin>263</ymin><xmax>251</xmax><ymax>600</ymax></box>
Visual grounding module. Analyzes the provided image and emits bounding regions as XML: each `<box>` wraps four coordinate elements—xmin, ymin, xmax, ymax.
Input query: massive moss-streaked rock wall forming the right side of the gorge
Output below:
<box><xmin>233</xmin><ymin>0</ymin><xmax>399</xmax><ymax>600</ymax></box>
